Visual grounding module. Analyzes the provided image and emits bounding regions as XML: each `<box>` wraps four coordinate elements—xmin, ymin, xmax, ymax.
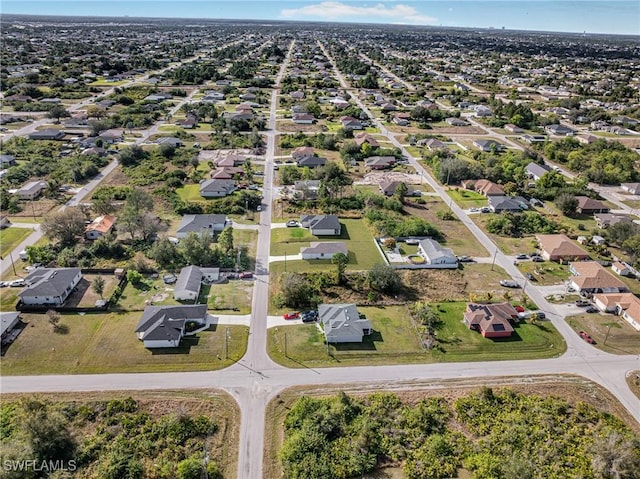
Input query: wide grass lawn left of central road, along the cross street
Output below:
<box><xmin>0</xmin><ymin>312</ymin><xmax>248</xmax><ymax>376</ymax></box>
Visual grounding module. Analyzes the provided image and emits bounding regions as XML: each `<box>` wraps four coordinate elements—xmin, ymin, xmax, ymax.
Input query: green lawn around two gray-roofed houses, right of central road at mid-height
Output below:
<box><xmin>271</xmin><ymin>219</ymin><xmax>383</xmax><ymax>271</ymax></box>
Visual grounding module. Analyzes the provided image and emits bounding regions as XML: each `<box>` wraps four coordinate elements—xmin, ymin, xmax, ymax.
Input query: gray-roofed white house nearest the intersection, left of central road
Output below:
<box><xmin>135</xmin><ymin>304</ymin><xmax>207</xmax><ymax>348</ymax></box>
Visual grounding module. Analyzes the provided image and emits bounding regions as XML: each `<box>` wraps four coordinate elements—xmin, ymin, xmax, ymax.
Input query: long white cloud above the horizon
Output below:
<box><xmin>280</xmin><ymin>2</ymin><xmax>437</xmax><ymax>25</ymax></box>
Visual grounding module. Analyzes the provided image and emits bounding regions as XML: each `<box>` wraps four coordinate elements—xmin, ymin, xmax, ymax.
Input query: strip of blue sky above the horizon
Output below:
<box><xmin>0</xmin><ymin>0</ymin><xmax>640</xmax><ymax>35</ymax></box>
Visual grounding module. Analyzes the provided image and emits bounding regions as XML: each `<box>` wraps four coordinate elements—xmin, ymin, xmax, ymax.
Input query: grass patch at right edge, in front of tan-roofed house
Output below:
<box><xmin>566</xmin><ymin>313</ymin><xmax>640</xmax><ymax>354</ymax></box>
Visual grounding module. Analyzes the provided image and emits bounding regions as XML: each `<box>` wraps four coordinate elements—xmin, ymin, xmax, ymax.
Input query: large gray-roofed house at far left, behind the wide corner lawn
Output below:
<box><xmin>18</xmin><ymin>268</ymin><xmax>82</xmax><ymax>306</ymax></box>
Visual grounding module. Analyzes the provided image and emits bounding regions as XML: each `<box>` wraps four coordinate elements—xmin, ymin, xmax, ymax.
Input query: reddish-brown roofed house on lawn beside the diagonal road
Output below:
<box><xmin>463</xmin><ymin>303</ymin><xmax>518</xmax><ymax>338</ymax></box>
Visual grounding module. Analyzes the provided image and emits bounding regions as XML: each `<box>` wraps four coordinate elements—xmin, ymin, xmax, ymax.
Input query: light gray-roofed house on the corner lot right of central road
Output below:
<box><xmin>318</xmin><ymin>304</ymin><xmax>373</xmax><ymax>343</ymax></box>
